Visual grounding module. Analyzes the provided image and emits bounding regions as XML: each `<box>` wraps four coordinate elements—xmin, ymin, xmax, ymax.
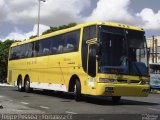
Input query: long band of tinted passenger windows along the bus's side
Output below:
<box><xmin>10</xmin><ymin>30</ymin><xmax>80</xmax><ymax>60</ymax></box>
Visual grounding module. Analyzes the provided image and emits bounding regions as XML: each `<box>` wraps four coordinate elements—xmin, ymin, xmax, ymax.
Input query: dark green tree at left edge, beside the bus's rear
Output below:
<box><xmin>0</xmin><ymin>40</ymin><xmax>14</xmax><ymax>81</ymax></box>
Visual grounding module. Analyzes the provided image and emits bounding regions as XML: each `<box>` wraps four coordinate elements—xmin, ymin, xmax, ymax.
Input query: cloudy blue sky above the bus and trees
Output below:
<box><xmin>0</xmin><ymin>0</ymin><xmax>160</xmax><ymax>41</ymax></box>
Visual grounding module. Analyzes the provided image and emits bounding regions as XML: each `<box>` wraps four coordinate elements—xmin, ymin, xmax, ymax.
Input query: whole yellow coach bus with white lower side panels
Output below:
<box><xmin>7</xmin><ymin>22</ymin><xmax>149</xmax><ymax>102</ymax></box>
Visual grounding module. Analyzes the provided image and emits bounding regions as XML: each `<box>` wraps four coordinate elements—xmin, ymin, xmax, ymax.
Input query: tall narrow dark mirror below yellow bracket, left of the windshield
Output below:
<box><xmin>88</xmin><ymin>45</ymin><xmax>96</xmax><ymax>77</ymax></box>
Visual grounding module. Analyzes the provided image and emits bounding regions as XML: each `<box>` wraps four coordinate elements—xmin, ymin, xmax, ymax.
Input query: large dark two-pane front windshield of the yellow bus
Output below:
<box><xmin>99</xmin><ymin>26</ymin><xmax>148</xmax><ymax>75</ymax></box>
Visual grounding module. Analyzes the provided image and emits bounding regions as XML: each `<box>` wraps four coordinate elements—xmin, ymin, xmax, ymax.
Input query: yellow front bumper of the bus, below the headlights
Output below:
<box><xmin>97</xmin><ymin>83</ymin><xmax>150</xmax><ymax>97</ymax></box>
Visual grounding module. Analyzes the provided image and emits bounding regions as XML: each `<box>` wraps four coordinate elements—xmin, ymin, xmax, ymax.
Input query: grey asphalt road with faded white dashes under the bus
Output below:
<box><xmin>0</xmin><ymin>85</ymin><xmax>160</xmax><ymax>120</ymax></box>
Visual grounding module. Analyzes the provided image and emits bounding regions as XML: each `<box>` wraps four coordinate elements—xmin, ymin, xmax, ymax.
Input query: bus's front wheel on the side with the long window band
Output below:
<box><xmin>74</xmin><ymin>80</ymin><xmax>82</xmax><ymax>101</ymax></box>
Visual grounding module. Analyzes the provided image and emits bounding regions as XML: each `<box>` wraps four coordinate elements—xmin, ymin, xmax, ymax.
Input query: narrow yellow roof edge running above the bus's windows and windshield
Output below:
<box><xmin>11</xmin><ymin>22</ymin><xmax>144</xmax><ymax>47</ymax></box>
